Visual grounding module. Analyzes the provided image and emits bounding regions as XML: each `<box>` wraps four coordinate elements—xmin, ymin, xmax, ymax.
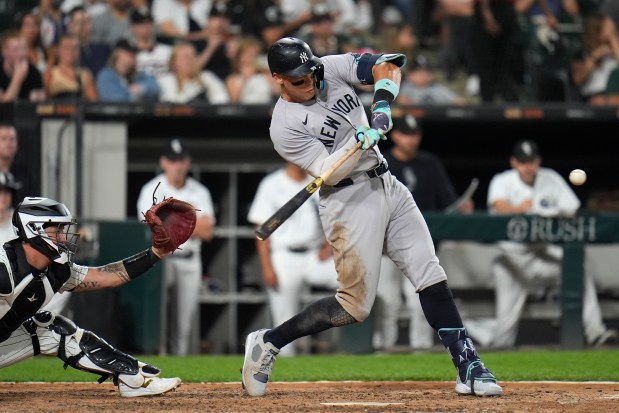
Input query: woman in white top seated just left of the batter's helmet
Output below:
<box><xmin>226</xmin><ymin>37</ymin><xmax>279</xmax><ymax>104</ymax></box>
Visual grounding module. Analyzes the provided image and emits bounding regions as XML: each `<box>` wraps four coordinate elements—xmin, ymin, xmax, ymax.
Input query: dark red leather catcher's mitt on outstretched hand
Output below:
<box><xmin>144</xmin><ymin>198</ymin><xmax>196</xmax><ymax>252</ymax></box>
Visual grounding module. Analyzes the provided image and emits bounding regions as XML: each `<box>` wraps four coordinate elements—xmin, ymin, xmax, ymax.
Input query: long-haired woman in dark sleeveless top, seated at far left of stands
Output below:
<box><xmin>43</xmin><ymin>35</ymin><xmax>97</xmax><ymax>102</ymax></box>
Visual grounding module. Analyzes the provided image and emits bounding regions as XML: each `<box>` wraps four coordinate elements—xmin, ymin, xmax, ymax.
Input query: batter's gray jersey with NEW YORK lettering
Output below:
<box><xmin>270</xmin><ymin>54</ymin><xmax>383</xmax><ymax>176</ymax></box>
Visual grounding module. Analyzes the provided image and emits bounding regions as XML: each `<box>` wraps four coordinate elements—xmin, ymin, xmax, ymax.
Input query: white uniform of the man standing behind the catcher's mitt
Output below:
<box><xmin>137</xmin><ymin>174</ymin><xmax>215</xmax><ymax>354</ymax></box>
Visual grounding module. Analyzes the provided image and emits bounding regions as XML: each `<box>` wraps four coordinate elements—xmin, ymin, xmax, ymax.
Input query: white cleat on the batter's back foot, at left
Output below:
<box><xmin>243</xmin><ymin>329</ymin><xmax>279</xmax><ymax>396</ymax></box>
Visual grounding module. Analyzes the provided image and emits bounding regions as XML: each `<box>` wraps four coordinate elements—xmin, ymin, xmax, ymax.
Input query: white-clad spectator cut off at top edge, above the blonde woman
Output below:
<box><xmin>152</xmin><ymin>0</ymin><xmax>211</xmax><ymax>42</ymax></box>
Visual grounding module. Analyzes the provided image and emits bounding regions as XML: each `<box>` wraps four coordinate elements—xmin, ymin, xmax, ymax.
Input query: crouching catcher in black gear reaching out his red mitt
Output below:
<box><xmin>0</xmin><ymin>198</ymin><xmax>195</xmax><ymax>397</ymax></box>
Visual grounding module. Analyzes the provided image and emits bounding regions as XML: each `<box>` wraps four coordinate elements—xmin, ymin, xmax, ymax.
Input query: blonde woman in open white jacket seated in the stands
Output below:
<box><xmin>158</xmin><ymin>43</ymin><xmax>230</xmax><ymax>104</ymax></box>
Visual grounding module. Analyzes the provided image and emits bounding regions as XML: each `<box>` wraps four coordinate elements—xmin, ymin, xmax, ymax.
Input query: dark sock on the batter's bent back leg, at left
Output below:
<box><xmin>264</xmin><ymin>296</ymin><xmax>357</xmax><ymax>348</ymax></box>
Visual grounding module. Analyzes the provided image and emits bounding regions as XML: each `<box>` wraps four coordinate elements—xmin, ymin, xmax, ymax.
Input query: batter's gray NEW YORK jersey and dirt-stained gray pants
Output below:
<box><xmin>270</xmin><ymin>54</ymin><xmax>447</xmax><ymax>321</ymax></box>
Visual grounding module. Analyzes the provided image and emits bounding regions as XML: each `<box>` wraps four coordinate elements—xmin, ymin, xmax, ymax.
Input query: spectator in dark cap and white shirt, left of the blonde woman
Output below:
<box><xmin>130</xmin><ymin>9</ymin><xmax>172</xmax><ymax>78</ymax></box>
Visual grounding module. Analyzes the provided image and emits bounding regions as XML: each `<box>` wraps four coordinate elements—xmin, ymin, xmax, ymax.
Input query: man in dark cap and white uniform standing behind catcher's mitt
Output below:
<box><xmin>137</xmin><ymin>138</ymin><xmax>215</xmax><ymax>355</ymax></box>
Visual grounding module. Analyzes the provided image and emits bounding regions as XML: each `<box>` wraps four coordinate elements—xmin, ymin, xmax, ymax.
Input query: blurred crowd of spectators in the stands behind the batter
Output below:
<box><xmin>0</xmin><ymin>0</ymin><xmax>619</xmax><ymax>105</ymax></box>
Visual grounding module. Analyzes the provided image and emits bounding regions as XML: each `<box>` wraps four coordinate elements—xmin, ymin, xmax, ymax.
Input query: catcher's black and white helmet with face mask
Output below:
<box><xmin>12</xmin><ymin>197</ymin><xmax>79</xmax><ymax>264</ymax></box>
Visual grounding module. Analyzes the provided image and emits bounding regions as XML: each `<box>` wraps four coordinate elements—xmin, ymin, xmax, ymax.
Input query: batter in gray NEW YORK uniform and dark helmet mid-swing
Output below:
<box><xmin>243</xmin><ymin>38</ymin><xmax>503</xmax><ymax>396</ymax></box>
